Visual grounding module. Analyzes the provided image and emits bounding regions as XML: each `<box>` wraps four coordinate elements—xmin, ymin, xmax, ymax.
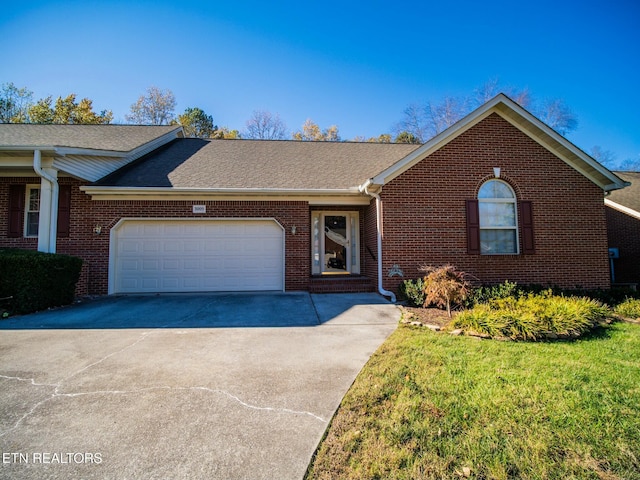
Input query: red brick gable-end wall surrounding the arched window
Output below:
<box><xmin>381</xmin><ymin>114</ymin><xmax>609</xmax><ymax>291</ymax></box>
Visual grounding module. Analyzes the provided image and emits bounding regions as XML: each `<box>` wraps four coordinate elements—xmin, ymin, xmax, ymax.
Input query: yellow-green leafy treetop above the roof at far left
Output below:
<box><xmin>28</xmin><ymin>93</ymin><xmax>113</xmax><ymax>125</ymax></box>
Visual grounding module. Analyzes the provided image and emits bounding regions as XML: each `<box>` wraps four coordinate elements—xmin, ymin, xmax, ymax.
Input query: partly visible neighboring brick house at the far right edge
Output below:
<box><xmin>604</xmin><ymin>172</ymin><xmax>640</xmax><ymax>285</ymax></box>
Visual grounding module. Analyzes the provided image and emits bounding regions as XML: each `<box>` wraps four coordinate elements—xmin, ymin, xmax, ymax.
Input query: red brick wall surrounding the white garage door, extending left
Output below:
<box><xmin>0</xmin><ymin>177</ymin><xmax>311</xmax><ymax>294</ymax></box>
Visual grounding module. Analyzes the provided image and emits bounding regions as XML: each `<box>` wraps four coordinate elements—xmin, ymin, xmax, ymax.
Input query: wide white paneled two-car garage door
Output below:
<box><xmin>110</xmin><ymin>219</ymin><xmax>284</xmax><ymax>293</ymax></box>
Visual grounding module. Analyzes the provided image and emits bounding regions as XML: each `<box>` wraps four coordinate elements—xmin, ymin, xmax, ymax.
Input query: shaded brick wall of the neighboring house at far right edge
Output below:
<box><xmin>606</xmin><ymin>207</ymin><xmax>640</xmax><ymax>283</ymax></box>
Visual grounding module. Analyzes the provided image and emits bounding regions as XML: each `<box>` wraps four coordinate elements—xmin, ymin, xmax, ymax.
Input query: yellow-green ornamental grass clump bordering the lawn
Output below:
<box><xmin>452</xmin><ymin>290</ymin><xmax>609</xmax><ymax>341</ymax></box>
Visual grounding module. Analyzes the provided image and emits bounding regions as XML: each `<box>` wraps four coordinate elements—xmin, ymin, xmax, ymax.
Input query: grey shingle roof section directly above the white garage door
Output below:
<box><xmin>96</xmin><ymin>138</ymin><xmax>418</xmax><ymax>190</ymax></box>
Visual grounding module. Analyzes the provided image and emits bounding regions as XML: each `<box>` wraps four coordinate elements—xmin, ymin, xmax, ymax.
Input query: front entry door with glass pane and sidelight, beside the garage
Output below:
<box><xmin>311</xmin><ymin>212</ymin><xmax>360</xmax><ymax>275</ymax></box>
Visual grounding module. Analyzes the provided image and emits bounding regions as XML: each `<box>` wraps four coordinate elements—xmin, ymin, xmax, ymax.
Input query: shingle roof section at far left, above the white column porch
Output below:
<box><xmin>0</xmin><ymin>123</ymin><xmax>179</xmax><ymax>152</ymax></box>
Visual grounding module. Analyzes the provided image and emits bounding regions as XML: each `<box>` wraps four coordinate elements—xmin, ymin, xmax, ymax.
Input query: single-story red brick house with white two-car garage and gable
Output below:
<box><xmin>0</xmin><ymin>95</ymin><xmax>626</xmax><ymax>295</ymax></box>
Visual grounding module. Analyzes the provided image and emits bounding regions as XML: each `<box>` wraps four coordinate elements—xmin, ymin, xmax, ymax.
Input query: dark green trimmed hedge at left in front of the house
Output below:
<box><xmin>0</xmin><ymin>249</ymin><xmax>82</xmax><ymax>314</ymax></box>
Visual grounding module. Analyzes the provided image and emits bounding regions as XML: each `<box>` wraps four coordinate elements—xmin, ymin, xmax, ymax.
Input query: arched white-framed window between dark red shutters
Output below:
<box><xmin>478</xmin><ymin>179</ymin><xmax>518</xmax><ymax>255</ymax></box>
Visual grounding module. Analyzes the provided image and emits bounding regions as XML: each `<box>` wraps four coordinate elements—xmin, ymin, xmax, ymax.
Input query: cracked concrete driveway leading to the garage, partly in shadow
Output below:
<box><xmin>0</xmin><ymin>293</ymin><xmax>399</xmax><ymax>479</ymax></box>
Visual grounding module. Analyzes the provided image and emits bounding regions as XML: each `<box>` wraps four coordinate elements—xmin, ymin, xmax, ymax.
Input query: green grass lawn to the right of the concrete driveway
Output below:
<box><xmin>306</xmin><ymin>323</ymin><xmax>640</xmax><ymax>480</ymax></box>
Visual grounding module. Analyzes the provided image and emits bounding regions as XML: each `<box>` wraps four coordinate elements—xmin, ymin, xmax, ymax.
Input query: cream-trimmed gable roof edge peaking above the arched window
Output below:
<box><xmin>368</xmin><ymin>94</ymin><xmax>627</xmax><ymax>191</ymax></box>
